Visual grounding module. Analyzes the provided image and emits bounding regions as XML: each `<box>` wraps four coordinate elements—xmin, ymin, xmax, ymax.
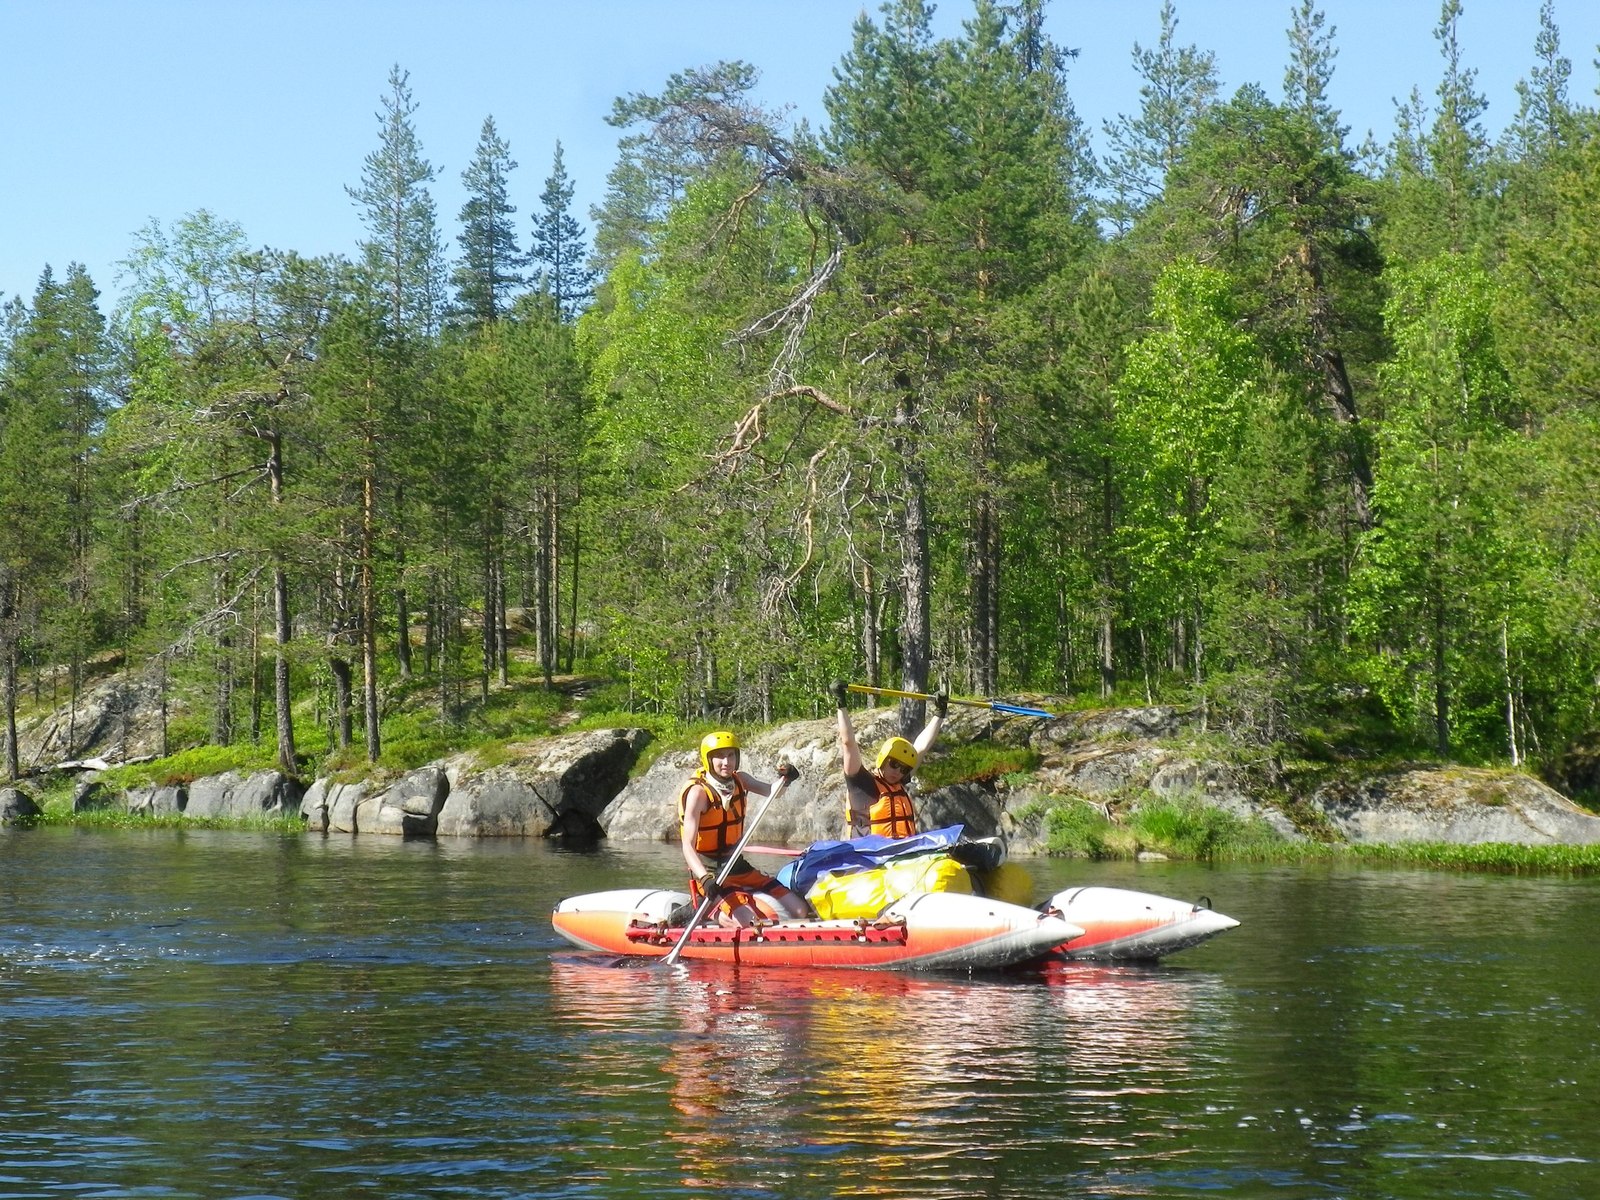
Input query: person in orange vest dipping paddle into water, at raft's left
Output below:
<box><xmin>678</xmin><ymin>730</ymin><xmax>810</xmax><ymax>925</ymax></box>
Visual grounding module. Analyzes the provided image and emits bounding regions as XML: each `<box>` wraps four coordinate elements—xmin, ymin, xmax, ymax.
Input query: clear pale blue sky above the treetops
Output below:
<box><xmin>0</xmin><ymin>0</ymin><xmax>1600</xmax><ymax>309</ymax></box>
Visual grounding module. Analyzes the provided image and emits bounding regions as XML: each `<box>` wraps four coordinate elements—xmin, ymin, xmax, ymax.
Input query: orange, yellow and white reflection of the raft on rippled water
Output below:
<box><xmin>550</xmin><ymin>955</ymin><xmax>1227</xmax><ymax>1197</ymax></box>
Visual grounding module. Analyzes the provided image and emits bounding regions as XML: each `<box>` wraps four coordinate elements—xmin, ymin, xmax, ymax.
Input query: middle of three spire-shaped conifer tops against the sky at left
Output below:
<box><xmin>453</xmin><ymin>117</ymin><xmax>526</xmax><ymax>325</ymax></box>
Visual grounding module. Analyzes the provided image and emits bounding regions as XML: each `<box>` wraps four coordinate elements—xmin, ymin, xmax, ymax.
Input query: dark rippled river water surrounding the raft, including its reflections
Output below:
<box><xmin>0</xmin><ymin>829</ymin><xmax>1600</xmax><ymax>1200</ymax></box>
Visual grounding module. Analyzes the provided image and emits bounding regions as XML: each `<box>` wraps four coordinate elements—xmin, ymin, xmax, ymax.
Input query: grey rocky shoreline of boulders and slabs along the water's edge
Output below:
<box><xmin>0</xmin><ymin>706</ymin><xmax>1600</xmax><ymax>854</ymax></box>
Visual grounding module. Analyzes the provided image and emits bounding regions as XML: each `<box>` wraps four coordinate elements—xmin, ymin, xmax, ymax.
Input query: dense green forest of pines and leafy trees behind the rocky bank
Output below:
<box><xmin>0</xmin><ymin>0</ymin><xmax>1600</xmax><ymax>790</ymax></box>
